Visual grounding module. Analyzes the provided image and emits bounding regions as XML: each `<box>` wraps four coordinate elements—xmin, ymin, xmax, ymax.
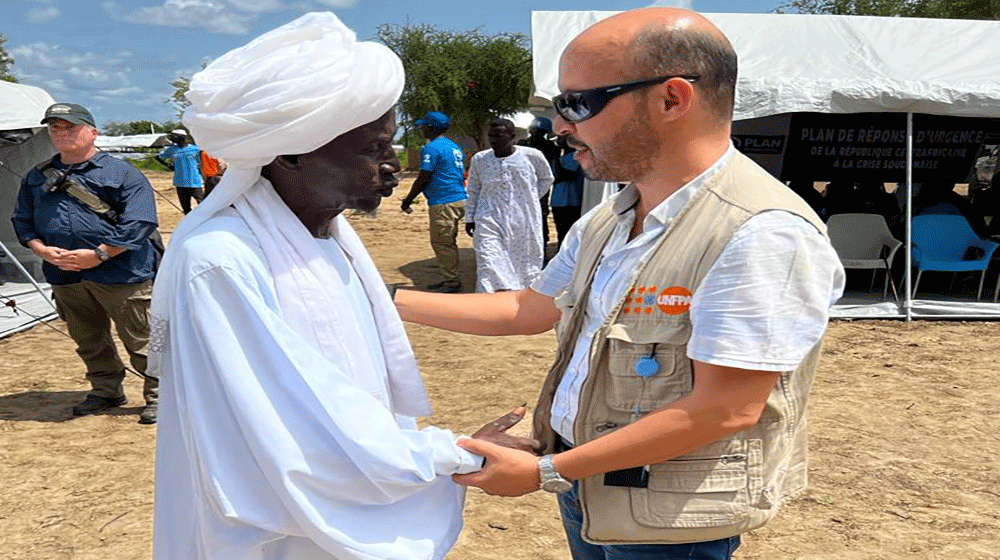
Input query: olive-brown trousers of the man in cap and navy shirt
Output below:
<box><xmin>52</xmin><ymin>280</ymin><xmax>160</xmax><ymax>404</ymax></box>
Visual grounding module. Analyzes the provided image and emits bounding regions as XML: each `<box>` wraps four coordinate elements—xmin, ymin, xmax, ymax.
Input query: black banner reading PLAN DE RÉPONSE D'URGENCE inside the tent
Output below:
<box><xmin>781</xmin><ymin>113</ymin><xmax>997</xmax><ymax>182</ymax></box>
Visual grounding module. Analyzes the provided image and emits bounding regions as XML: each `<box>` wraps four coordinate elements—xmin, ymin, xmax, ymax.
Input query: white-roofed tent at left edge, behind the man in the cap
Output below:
<box><xmin>0</xmin><ymin>81</ymin><xmax>55</xmax><ymax>338</ymax></box>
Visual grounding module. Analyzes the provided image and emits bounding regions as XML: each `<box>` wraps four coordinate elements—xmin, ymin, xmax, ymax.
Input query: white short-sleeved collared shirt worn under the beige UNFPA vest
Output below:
<box><xmin>531</xmin><ymin>144</ymin><xmax>844</xmax><ymax>444</ymax></box>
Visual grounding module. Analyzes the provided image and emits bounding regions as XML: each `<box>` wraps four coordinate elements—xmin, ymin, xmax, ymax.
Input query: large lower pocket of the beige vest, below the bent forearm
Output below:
<box><xmin>629</xmin><ymin>440</ymin><xmax>763</xmax><ymax>528</ymax></box>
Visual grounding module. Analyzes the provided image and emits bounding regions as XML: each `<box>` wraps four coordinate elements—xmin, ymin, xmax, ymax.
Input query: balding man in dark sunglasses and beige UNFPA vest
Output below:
<box><xmin>396</xmin><ymin>8</ymin><xmax>844</xmax><ymax>560</ymax></box>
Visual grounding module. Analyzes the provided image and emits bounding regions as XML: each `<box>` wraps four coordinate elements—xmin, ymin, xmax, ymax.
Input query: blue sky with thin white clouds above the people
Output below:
<box><xmin>0</xmin><ymin>0</ymin><xmax>780</xmax><ymax>126</ymax></box>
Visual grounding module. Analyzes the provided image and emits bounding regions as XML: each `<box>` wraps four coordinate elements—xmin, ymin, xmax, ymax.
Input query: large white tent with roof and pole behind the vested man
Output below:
<box><xmin>531</xmin><ymin>11</ymin><xmax>1000</xmax><ymax>318</ymax></box>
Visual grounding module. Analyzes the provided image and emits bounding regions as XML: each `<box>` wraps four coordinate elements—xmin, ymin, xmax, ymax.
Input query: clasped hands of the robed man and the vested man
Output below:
<box><xmin>452</xmin><ymin>406</ymin><xmax>542</xmax><ymax>496</ymax></box>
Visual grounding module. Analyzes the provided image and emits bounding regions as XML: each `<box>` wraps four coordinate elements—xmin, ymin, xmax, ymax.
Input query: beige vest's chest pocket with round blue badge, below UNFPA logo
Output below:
<box><xmin>604</xmin><ymin>337</ymin><xmax>692</xmax><ymax>414</ymax></box>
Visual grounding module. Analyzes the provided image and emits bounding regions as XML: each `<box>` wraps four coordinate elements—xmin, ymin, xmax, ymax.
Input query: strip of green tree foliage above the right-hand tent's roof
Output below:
<box><xmin>775</xmin><ymin>0</ymin><xmax>1000</xmax><ymax>19</ymax></box>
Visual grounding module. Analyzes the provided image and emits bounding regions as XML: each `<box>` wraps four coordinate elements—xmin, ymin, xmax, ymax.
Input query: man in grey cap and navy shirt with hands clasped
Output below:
<box><xmin>11</xmin><ymin>103</ymin><xmax>159</xmax><ymax>424</ymax></box>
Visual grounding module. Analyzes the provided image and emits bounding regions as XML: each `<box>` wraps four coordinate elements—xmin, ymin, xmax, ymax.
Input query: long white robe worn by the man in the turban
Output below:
<box><xmin>151</xmin><ymin>182</ymin><xmax>480</xmax><ymax>560</ymax></box>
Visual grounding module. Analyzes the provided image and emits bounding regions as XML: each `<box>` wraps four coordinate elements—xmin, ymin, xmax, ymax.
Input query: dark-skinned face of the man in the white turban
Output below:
<box><xmin>279</xmin><ymin>110</ymin><xmax>400</xmax><ymax>235</ymax></box>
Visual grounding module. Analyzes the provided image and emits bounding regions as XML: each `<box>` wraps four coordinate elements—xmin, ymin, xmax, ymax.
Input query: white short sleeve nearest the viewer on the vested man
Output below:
<box><xmin>688</xmin><ymin>211</ymin><xmax>844</xmax><ymax>371</ymax></box>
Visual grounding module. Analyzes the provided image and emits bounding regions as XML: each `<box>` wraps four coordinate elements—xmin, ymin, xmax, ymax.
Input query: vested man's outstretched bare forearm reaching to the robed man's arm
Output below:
<box><xmin>395</xmin><ymin>289</ymin><xmax>559</xmax><ymax>336</ymax></box>
